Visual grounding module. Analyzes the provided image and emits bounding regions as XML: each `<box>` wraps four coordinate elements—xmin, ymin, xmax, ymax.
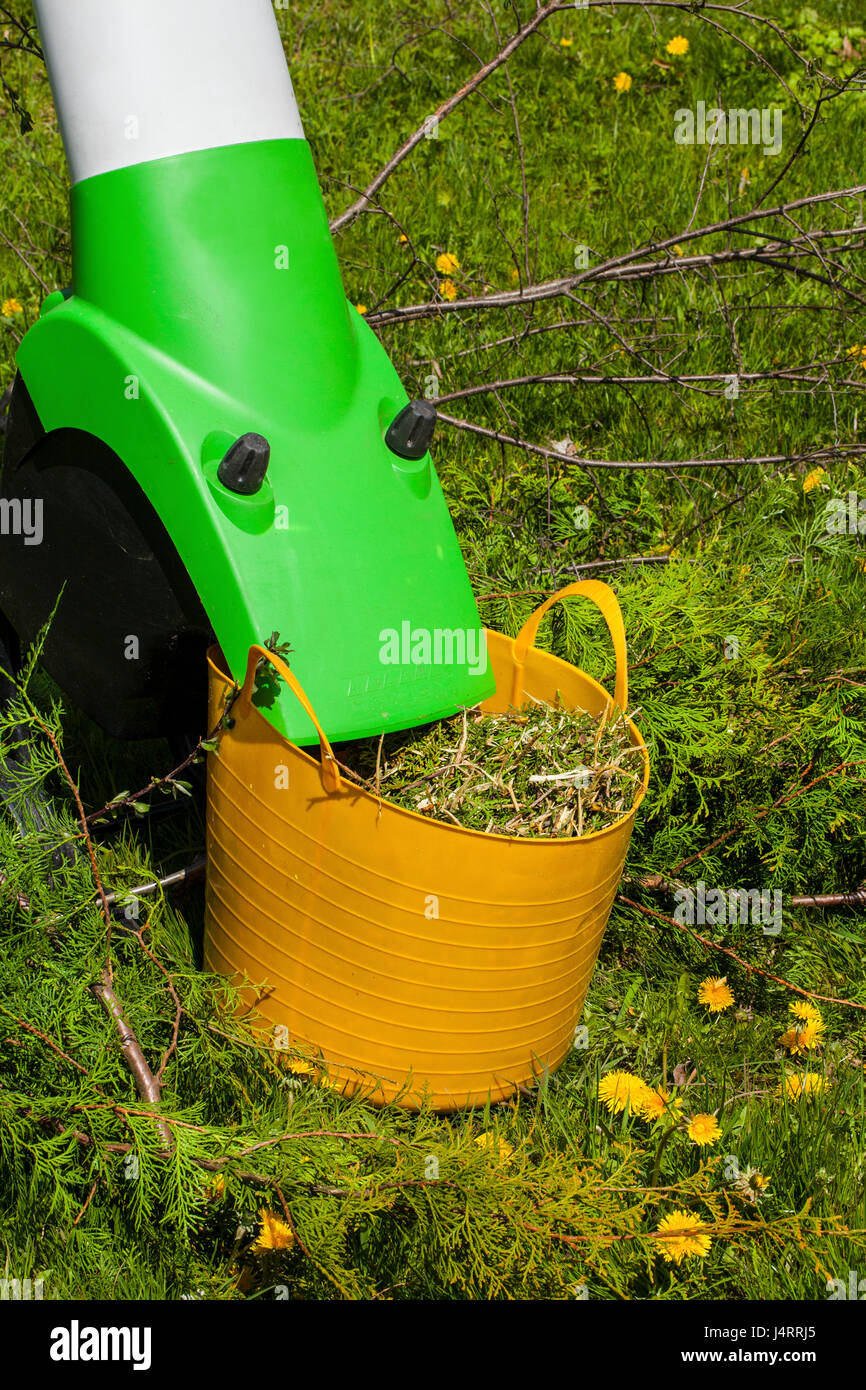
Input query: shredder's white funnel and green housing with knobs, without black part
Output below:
<box><xmin>7</xmin><ymin>0</ymin><xmax>493</xmax><ymax>744</ymax></box>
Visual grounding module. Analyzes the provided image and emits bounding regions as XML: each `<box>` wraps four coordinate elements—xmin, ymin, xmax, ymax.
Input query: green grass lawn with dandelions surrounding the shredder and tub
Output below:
<box><xmin>0</xmin><ymin>0</ymin><xmax>866</xmax><ymax>1300</ymax></box>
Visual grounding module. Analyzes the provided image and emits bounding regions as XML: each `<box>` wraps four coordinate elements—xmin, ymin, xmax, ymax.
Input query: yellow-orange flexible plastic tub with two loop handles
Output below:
<box><xmin>204</xmin><ymin>580</ymin><xmax>649</xmax><ymax>1109</ymax></box>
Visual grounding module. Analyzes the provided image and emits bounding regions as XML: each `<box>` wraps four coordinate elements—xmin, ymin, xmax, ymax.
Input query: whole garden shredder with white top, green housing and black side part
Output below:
<box><xmin>0</xmin><ymin>0</ymin><xmax>492</xmax><ymax>744</ymax></box>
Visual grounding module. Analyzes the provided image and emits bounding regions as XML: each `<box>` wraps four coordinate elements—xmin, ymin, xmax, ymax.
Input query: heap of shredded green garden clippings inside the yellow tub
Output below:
<box><xmin>334</xmin><ymin>701</ymin><xmax>642</xmax><ymax>838</ymax></box>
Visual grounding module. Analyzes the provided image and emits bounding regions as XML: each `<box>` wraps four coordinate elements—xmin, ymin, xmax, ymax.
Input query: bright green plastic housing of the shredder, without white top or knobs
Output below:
<box><xmin>18</xmin><ymin>139</ymin><xmax>493</xmax><ymax>744</ymax></box>
